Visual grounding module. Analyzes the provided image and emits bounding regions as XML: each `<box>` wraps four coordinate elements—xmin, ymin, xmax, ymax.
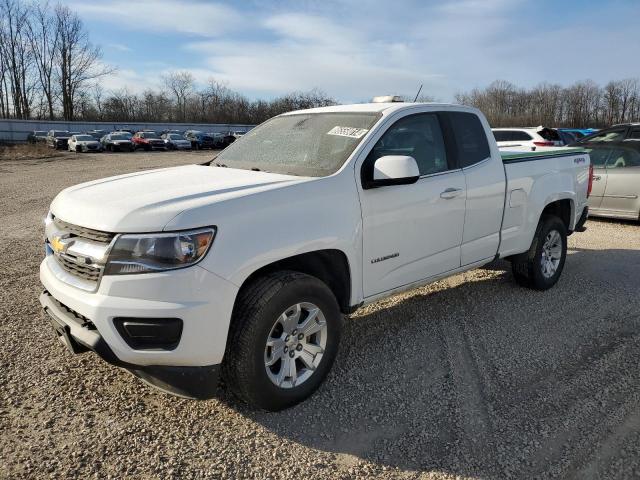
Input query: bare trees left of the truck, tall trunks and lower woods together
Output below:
<box><xmin>0</xmin><ymin>0</ymin><xmax>336</xmax><ymax>124</ymax></box>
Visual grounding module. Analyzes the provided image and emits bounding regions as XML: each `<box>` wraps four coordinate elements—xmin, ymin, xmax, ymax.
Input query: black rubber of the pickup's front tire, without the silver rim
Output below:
<box><xmin>223</xmin><ymin>271</ymin><xmax>343</xmax><ymax>411</ymax></box>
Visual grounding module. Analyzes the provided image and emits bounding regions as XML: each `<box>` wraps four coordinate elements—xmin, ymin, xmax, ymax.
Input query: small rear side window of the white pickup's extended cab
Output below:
<box><xmin>446</xmin><ymin>112</ymin><xmax>491</xmax><ymax>168</ymax></box>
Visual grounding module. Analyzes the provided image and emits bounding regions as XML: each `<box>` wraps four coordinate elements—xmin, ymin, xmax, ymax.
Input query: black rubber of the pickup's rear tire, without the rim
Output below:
<box><xmin>511</xmin><ymin>215</ymin><xmax>567</xmax><ymax>290</ymax></box>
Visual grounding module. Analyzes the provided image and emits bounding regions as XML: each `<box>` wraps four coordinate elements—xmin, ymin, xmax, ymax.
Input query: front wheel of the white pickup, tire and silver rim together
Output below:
<box><xmin>223</xmin><ymin>271</ymin><xmax>343</xmax><ymax>411</ymax></box>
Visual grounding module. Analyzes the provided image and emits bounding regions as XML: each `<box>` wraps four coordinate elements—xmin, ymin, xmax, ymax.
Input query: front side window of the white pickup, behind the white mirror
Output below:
<box><xmin>363</xmin><ymin>113</ymin><xmax>449</xmax><ymax>175</ymax></box>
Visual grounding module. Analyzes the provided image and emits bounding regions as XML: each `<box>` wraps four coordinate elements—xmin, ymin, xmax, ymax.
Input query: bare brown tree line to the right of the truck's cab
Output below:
<box><xmin>456</xmin><ymin>78</ymin><xmax>640</xmax><ymax>128</ymax></box>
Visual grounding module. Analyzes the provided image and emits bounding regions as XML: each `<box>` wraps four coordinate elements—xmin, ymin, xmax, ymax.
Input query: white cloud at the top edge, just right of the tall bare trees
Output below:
<box><xmin>71</xmin><ymin>0</ymin><xmax>242</xmax><ymax>37</ymax></box>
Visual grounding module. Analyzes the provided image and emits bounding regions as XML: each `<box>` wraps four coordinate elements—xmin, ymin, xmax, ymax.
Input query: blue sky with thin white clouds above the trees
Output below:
<box><xmin>63</xmin><ymin>0</ymin><xmax>640</xmax><ymax>103</ymax></box>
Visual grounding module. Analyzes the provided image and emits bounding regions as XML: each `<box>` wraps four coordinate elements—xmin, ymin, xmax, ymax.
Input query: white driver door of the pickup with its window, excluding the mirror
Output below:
<box><xmin>360</xmin><ymin>113</ymin><xmax>466</xmax><ymax>298</ymax></box>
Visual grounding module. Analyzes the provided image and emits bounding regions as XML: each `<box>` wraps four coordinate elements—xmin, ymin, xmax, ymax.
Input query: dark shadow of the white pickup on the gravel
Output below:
<box><xmin>232</xmin><ymin>249</ymin><xmax>640</xmax><ymax>478</ymax></box>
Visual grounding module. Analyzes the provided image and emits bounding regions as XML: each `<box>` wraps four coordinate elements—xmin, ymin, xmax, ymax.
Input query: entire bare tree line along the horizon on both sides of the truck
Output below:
<box><xmin>0</xmin><ymin>0</ymin><xmax>640</xmax><ymax>127</ymax></box>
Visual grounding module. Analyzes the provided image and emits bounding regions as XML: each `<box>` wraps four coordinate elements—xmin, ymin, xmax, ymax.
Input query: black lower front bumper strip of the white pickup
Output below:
<box><xmin>40</xmin><ymin>290</ymin><xmax>220</xmax><ymax>399</ymax></box>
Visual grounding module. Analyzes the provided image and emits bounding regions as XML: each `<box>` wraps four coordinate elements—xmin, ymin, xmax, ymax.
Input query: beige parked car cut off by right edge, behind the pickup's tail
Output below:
<box><xmin>581</xmin><ymin>139</ymin><xmax>640</xmax><ymax>220</ymax></box>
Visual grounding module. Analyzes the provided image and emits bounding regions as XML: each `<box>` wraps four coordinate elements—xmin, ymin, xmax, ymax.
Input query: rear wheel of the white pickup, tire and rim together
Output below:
<box><xmin>511</xmin><ymin>215</ymin><xmax>567</xmax><ymax>290</ymax></box>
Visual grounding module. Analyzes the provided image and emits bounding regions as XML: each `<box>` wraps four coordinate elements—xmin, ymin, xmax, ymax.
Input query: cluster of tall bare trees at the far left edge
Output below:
<box><xmin>0</xmin><ymin>0</ymin><xmax>113</xmax><ymax>120</ymax></box>
